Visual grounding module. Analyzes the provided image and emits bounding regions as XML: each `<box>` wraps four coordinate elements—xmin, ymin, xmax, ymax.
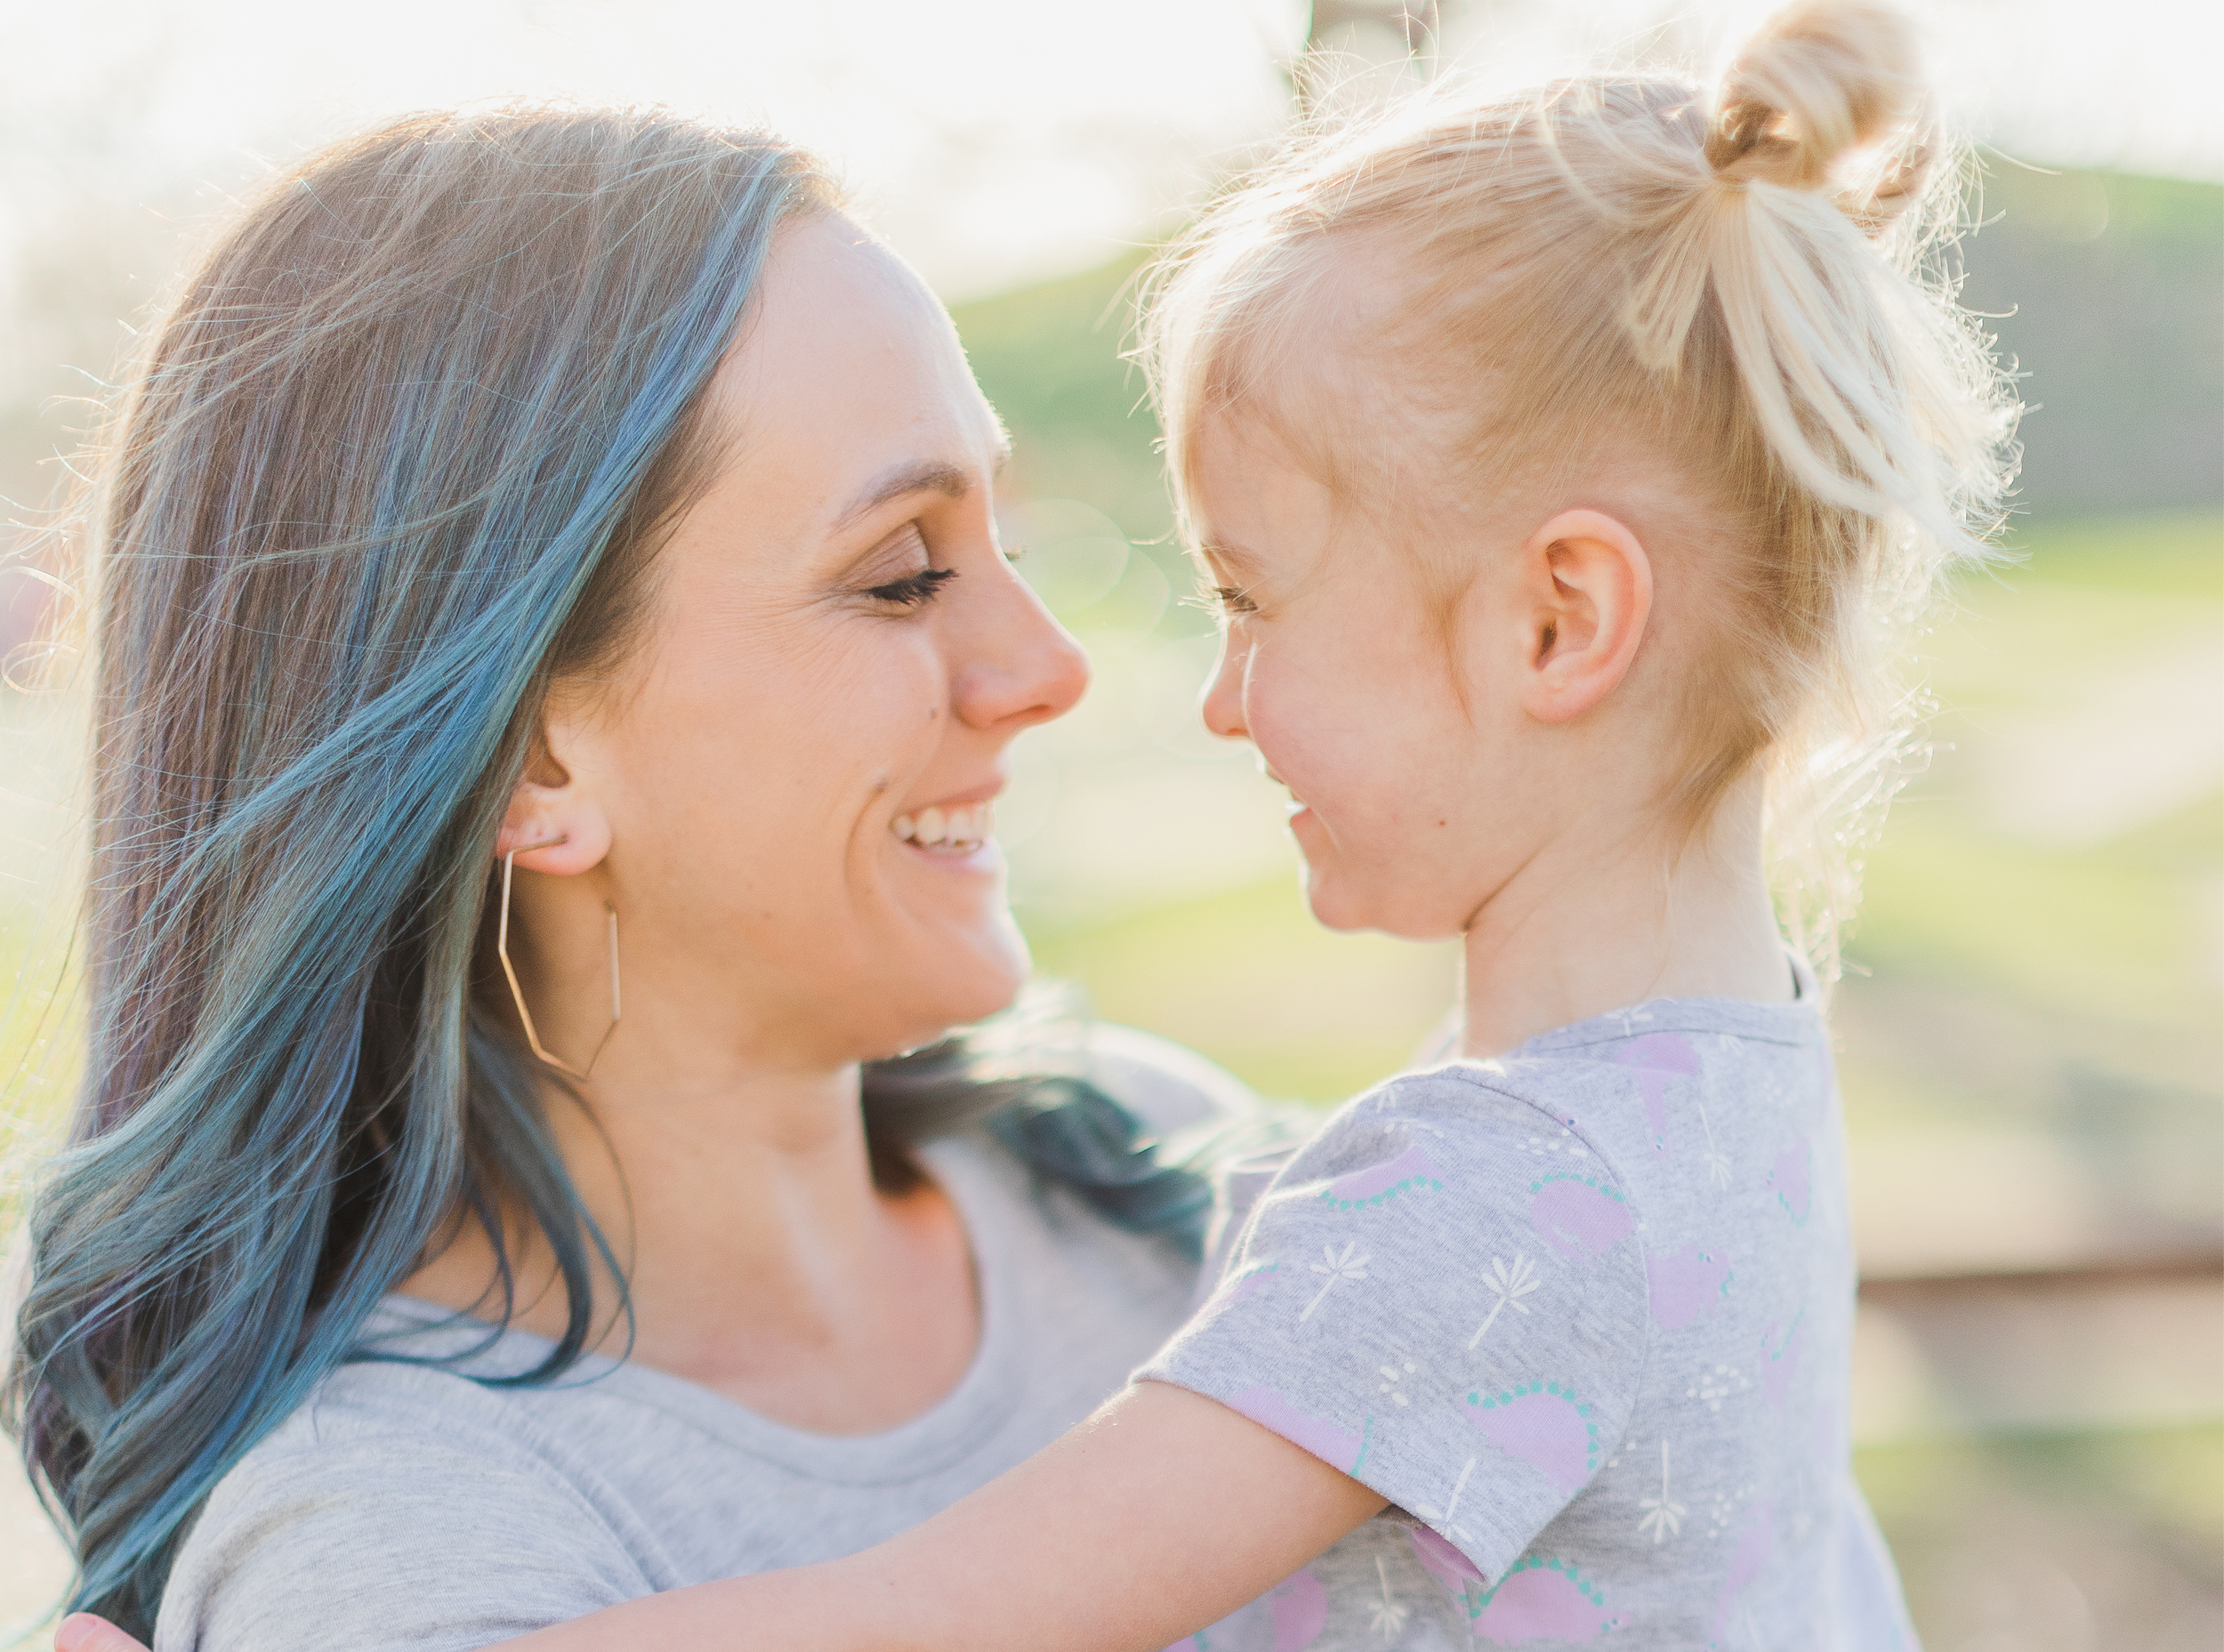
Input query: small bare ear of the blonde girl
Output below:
<box><xmin>1519</xmin><ymin>512</ymin><xmax>1653</xmax><ymax>722</ymax></box>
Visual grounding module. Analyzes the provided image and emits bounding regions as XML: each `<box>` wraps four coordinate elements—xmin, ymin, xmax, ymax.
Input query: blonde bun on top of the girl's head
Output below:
<box><xmin>1706</xmin><ymin>0</ymin><xmax>1922</xmax><ymax>193</ymax></box>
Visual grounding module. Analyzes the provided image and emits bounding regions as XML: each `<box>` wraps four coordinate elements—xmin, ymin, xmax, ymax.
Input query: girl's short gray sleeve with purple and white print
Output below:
<box><xmin>1139</xmin><ymin>1072</ymin><xmax>1650</xmax><ymax>1581</ymax></box>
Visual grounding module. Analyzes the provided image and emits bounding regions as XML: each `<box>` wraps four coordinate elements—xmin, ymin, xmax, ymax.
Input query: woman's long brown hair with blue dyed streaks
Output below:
<box><xmin>7</xmin><ymin>109</ymin><xmax>1204</xmax><ymax>1637</ymax></box>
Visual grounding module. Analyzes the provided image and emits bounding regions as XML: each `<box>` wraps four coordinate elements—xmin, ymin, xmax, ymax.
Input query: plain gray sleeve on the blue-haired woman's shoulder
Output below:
<box><xmin>154</xmin><ymin>1387</ymin><xmax>657</xmax><ymax>1652</ymax></box>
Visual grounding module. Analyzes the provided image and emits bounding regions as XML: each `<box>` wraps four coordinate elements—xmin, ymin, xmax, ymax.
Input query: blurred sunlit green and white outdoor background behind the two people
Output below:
<box><xmin>0</xmin><ymin>0</ymin><xmax>2224</xmax><ymax>1652</ymax></box>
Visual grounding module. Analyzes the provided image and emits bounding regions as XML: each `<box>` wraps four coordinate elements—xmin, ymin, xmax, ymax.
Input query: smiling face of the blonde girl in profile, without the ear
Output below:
<box><xmin>1190</xmin><ymin>420</ymin><xmax>1610</xmax><ymax>939</ymax></box>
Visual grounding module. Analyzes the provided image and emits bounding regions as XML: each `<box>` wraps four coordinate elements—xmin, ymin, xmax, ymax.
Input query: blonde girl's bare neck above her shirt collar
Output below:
<box><xmin>1459</xmin><ymin>780</ymin><xmax>1795</xmax><ymax>1059</ymax></box>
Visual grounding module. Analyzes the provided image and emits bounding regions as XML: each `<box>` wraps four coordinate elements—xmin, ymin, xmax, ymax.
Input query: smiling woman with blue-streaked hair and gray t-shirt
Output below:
<box><xmin>12</xmin><ymin>111</ymin><xmax>1254</xmax><ymax>1652</ymax></box>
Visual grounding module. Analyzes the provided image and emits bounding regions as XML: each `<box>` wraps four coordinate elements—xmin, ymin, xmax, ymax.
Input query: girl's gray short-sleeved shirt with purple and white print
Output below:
<box><xmin>1141</xmin><ymin>967</ymin><xmax>1915</xmax><ymax>1652</ymax></box>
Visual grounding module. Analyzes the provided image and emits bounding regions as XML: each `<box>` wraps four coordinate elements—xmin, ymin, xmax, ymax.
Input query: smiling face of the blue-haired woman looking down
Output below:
<box><xmin>503</xmin><ymin>215</ymin><xmax>1088</xmax><ymax>1081</ymax></box>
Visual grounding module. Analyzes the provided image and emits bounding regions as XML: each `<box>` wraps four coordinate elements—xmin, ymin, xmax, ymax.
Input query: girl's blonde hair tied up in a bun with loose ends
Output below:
<box><xmin>1143</xmin><ymin>0</ymin><xmax>2013</xmax><ymax>979</ymax></box>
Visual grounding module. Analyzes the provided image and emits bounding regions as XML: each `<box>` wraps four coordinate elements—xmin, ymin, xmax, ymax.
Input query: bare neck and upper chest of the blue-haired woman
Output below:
<box><xmin>403</xmin><ymin>1068</ymin><xmax>979</xmax><ymax>1434</ymax></box>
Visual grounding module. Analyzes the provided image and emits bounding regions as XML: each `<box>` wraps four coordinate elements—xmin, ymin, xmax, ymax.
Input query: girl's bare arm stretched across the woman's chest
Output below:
<box><xmin>503</xmin><ymin>1383</ymin><xmax>1383</xmax><ymax>1652</ymax></box>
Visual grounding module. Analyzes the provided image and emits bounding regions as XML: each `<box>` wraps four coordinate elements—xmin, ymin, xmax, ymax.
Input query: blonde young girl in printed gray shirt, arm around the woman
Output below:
<box><xmin>125</xmin><ymin>4</ymin><xmax>2006</xmax><ymax>1652</ymax></box>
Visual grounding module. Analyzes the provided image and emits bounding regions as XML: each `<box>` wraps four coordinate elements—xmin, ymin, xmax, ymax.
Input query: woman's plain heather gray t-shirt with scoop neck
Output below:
<box><xmin>154</xmin><ymin>1029</ymin><xmax>1244</xmax><ymax>1652</ymax></box>
